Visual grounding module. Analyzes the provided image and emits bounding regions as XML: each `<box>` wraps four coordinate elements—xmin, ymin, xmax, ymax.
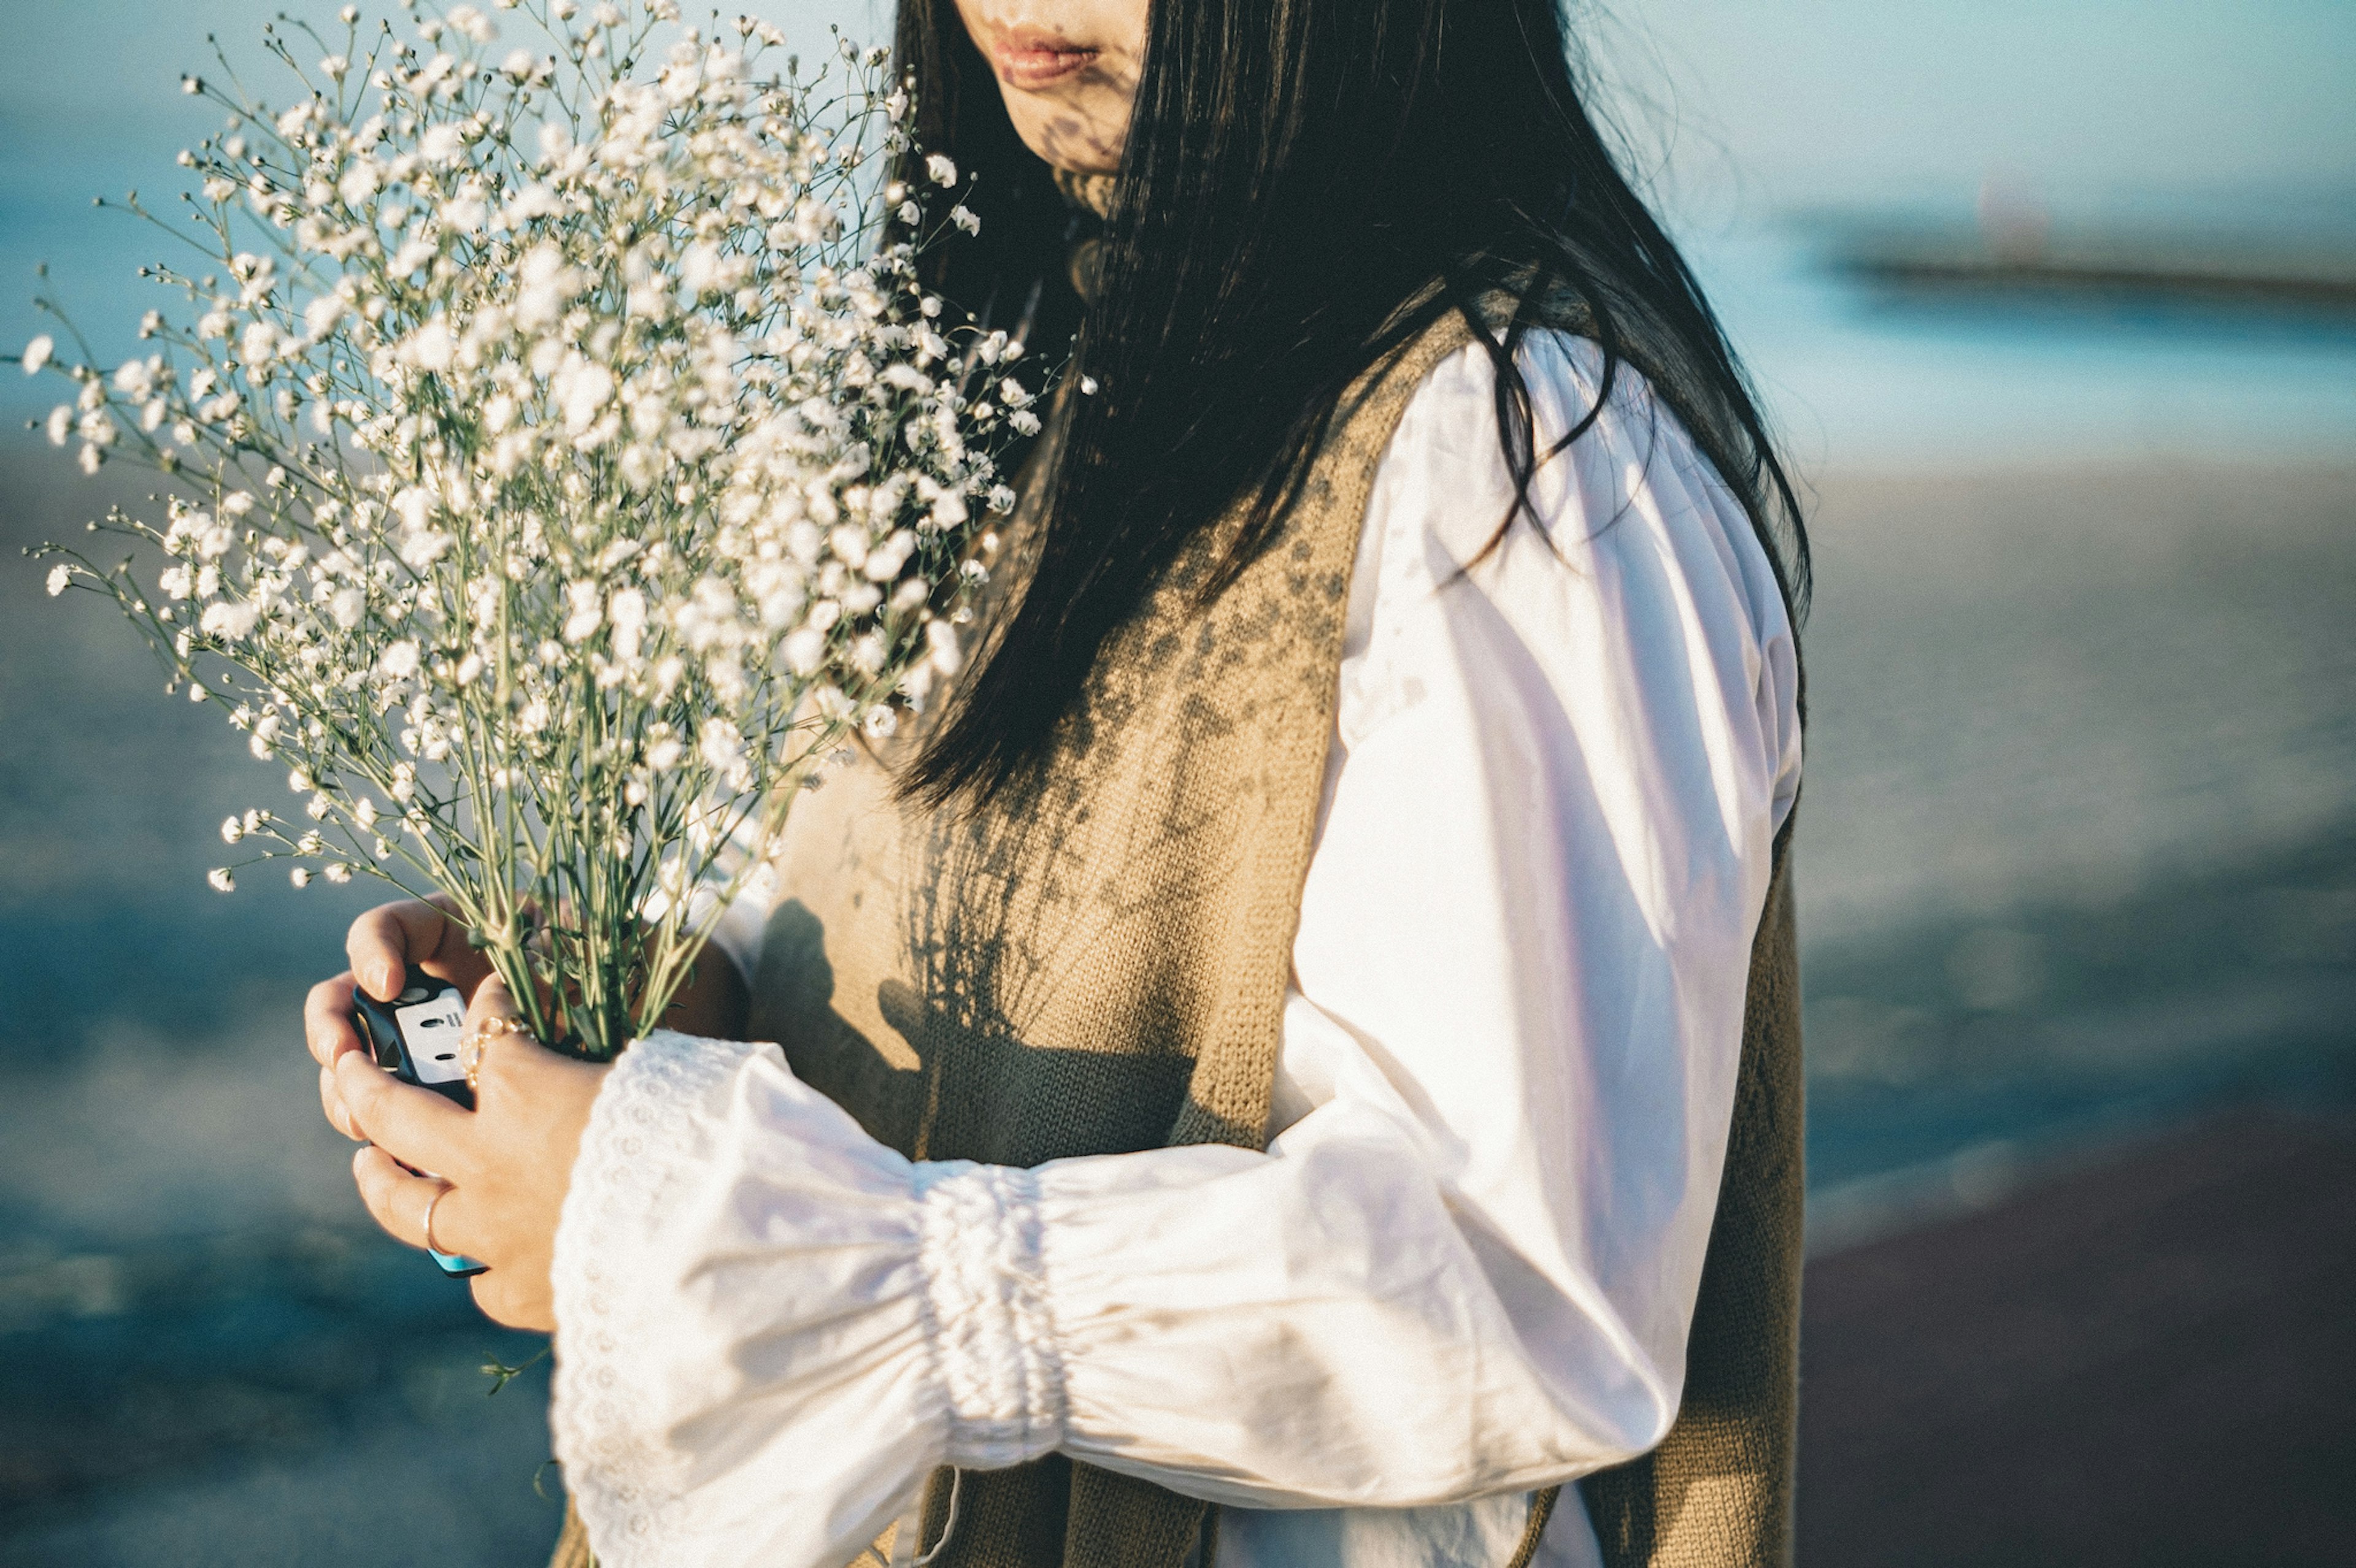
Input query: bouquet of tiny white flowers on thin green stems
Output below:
<box><xmin>21</xmin><ymin>0</ymin><xmax>1037</xmax><ymax>1057</ymax></box>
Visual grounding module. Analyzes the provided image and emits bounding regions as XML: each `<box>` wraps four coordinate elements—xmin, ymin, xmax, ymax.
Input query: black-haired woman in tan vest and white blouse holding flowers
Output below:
<box><xmin>306</xmin><ymin>0</ymin><xmax>1804</xmax><ymax>1568</ymax></box>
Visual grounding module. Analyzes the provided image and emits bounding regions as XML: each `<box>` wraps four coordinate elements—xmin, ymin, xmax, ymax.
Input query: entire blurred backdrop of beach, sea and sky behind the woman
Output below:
<box><xmin>0</xmin><ymin>0</ymin><xmax>2356</xmax><ymax>1568</ymax></box>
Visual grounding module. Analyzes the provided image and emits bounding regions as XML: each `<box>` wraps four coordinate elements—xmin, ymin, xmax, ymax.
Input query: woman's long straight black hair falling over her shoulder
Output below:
<box><xmin>898</xmin><ymin>0</ymin><xmax>1809</xmax><ymax>801</ymax></box>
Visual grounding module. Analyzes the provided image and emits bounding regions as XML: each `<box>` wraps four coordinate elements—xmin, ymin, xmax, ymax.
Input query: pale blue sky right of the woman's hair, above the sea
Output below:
<box><xmin>1598</xmin><ymin>0</ymin><xmax>2356</xmax><ymax>215</ymax></box>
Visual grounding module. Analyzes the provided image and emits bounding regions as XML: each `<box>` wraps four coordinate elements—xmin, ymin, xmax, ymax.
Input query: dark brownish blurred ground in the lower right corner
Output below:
<box><xmin>1800</xmin><ymin>1113</ymin><xmax>2356</xmax><ymax>1568</ymax></box>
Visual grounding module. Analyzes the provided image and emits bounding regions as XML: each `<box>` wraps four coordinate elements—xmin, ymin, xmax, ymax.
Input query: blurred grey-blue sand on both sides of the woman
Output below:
<box><xmin>0</xmin><ymin>438</ymin><xmax>2356</xmax><ymax>1568</ymax></box>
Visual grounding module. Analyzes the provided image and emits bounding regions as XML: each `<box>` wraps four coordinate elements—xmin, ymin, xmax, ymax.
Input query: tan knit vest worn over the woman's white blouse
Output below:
<box><xmin>558</xmin><ymin>299</ymin><xmax>1800</xmax><ymax>1568</ymax></box>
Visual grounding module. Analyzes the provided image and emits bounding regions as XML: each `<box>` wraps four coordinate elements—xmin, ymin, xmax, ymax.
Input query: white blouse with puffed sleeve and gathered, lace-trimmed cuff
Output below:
<box><xmin>553</xmin><ymin>334</ymin><xmax>1800</xmax><ymax>1568</ymax></box>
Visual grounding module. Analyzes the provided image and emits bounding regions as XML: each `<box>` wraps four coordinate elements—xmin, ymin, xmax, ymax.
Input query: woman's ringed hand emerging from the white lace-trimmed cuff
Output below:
<box><xmin>330</xmin><ymin>975</ymin><xmax>610</xmax><ymax>1332</ymax></box>
